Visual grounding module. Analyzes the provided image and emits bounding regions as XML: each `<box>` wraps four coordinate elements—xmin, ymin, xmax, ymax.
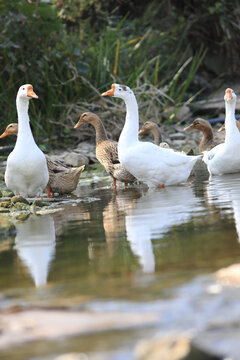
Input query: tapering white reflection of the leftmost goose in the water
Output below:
<box><xmin>15</xmin><ymin>215</ymin><xmax>56</xmax><ymax>287</ymax></box>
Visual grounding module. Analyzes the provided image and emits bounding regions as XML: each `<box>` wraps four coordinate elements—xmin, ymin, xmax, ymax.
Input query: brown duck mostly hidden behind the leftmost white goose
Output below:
<box><xmin>0</xmin><ymin>123</ymin><xmax>85</xmax><ymax>197</ymax></box>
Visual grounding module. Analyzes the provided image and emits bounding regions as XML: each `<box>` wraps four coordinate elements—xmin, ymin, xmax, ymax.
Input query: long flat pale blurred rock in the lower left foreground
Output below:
<box><xmin>0</xmin><ymin>308</ymin><xmax>156</xmax><ymax>349</ymax></box>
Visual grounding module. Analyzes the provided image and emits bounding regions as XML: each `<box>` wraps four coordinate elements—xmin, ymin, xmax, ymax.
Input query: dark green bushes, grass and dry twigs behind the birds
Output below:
<box><xmin>0</xmin><ymin>0</ymin><xmax>240</xmax><ymax>150</ymax></box>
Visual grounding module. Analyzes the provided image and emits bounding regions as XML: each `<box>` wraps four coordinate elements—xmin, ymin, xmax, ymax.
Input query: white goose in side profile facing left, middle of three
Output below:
<box><xmin>102</xmin><ymin>84</ymin><xmax>201</xmax><ymax>188</ymax></box>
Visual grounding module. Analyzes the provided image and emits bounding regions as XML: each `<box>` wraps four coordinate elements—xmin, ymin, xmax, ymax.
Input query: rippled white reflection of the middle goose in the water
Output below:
<box><xmin>125</xmin><ymin>185</ymin><xmax>198</xmax><ymax>273</ymax></box>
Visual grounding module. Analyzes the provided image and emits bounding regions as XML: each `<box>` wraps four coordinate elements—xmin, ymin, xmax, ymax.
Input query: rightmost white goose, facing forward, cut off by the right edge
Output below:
<box><xmin>203</xmin><ymin>88</ymin><xmax>240</xmax><ymax>175</ymax></box>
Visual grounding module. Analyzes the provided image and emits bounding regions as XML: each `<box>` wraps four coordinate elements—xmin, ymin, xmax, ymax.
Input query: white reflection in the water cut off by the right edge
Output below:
<box><xmin>206</xmin><ymin>174</ymin><xmax>240</xmax><ymax>242</ymax></box>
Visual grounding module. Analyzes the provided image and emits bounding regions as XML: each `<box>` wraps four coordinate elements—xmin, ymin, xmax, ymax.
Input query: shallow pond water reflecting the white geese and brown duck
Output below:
<box><xmin>0</xmin><ymin>174</ymin><xmax>240</xmax><ymax>360</ymax></box>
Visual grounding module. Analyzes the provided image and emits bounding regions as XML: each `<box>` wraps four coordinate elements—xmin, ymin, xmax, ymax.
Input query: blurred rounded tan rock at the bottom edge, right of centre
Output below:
<box><xmin>135</xmin><ymin>334</ymin><xmax>190</xmax><ymax>360</ymax></box>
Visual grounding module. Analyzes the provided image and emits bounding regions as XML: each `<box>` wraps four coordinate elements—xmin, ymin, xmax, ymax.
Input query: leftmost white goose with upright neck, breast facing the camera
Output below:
<box><xmin>5</xmin><ymin>84</ymin><xmax>49</xmax><ymax>197</ymax></box>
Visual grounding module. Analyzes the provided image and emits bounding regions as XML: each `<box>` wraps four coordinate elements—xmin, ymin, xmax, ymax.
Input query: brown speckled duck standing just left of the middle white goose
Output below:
<box><xmin>74</xmin><ymin>112</ymin><xmax>136</xmax><ymax>193</ymax></box>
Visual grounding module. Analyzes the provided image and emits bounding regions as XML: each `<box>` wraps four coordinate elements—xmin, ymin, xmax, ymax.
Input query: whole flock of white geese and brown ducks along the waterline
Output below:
<box><xmin>0</xmin><ymin>84</ymin><xmax>240</xmax><ymax>197</ymax></box>
